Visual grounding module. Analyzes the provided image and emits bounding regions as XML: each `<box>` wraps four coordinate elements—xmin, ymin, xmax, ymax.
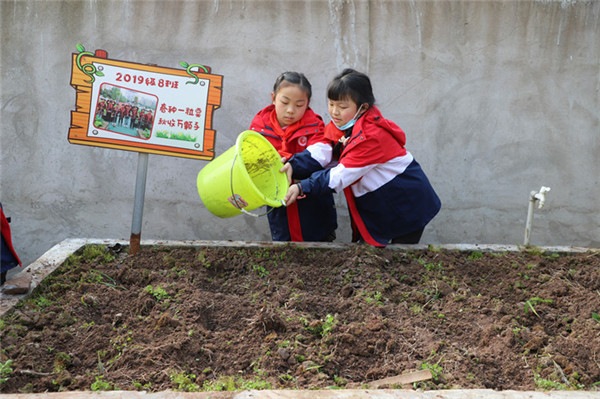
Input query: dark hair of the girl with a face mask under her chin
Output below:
<box><xmin>327</xmin><ymin>68</ymin><xmax>375</xmax><ymax>107</ymax></box>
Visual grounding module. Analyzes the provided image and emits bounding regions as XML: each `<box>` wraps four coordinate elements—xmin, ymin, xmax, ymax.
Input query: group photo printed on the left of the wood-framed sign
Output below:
<box><xmin>94</xmin><ymin>83</ymin><xmax>158</xmax><ymax>140</ymax></box>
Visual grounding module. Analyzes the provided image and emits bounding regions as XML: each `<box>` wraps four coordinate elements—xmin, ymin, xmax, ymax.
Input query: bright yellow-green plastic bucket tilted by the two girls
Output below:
<box><xmin>196</xmin><ymin>130</ymin><xmax>289</xmax><ymax>218</ymax></box>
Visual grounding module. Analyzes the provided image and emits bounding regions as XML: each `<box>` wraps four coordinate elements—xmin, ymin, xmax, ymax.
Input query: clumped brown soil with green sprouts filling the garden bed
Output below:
<box><xmin>0</xmin><ymin>245</ymin><xmax>600</xmax><ymax>393</ymax></box>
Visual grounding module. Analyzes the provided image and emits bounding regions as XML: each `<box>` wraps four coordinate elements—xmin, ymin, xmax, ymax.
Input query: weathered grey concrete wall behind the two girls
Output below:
<box><xmin>0</xmin><ymin>0</ymin><xmax>600</xmax><ymax>264</ymax></box>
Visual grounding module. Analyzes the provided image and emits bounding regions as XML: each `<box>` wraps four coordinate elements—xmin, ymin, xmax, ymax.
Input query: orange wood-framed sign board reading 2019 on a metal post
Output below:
<box><xmin>68</xmin><ymin>45</ymin><xmax>223</xmax><ymax>160</ymax></box>
